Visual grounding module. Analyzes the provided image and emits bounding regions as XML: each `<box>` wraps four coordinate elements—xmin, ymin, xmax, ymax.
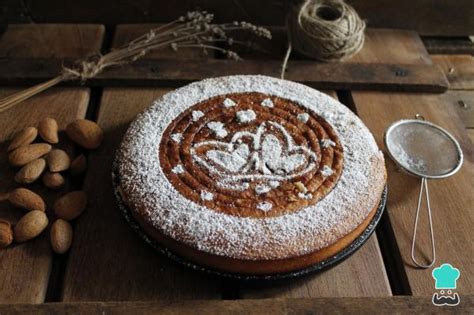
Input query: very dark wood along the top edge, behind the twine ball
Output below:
<box><xmin>0</xmin><ymin>0</ymin><xmax>474</xmax><ymax>36</ymax></box>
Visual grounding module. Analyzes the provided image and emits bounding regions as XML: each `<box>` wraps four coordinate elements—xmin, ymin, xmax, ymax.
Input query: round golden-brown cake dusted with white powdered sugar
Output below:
<box><xmin>116</xmin><ymin>75</ymin><xmax>386</xmax><ymax>275</ymax></box>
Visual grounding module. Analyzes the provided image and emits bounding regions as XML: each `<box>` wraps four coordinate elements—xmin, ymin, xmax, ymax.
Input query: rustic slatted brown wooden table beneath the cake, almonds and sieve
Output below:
<box><xmin>0</xmin><ymin>24</ymin><xmax>474</xmax><ymax>314</ymax></box>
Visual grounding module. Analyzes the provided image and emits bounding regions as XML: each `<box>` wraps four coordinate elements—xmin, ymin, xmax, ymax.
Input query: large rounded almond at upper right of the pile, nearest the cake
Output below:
<box><xmin>66</xmin><ymin>119</ymin><xmax>104</xmax><ymax>149</ymax></box>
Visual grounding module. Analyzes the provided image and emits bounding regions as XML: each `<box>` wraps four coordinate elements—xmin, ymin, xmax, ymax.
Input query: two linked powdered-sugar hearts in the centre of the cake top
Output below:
<box><xmin>191</xmin><ymin>121</ymin><xmax>318</xmax><ymax>190</ymax></box>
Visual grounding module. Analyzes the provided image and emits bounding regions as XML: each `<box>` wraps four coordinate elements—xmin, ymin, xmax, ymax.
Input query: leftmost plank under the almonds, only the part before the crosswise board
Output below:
<box><xmin>0</xmin><ymin>88</ymin><xmax>89</xmax><ymax>303</ymax></box>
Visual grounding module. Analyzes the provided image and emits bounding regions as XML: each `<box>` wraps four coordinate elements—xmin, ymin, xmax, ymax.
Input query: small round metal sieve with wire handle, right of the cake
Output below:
<box><xmin>384</xmin><ymin>114</ymin><xmax>463</xmax><ymax>268</ymax></box>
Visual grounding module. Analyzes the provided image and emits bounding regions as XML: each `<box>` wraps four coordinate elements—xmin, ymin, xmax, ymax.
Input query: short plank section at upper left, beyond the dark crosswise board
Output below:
<box><xmin>0</xmin><ymin>24</ymin><xmax>104</xmax><ymax>58</ymax></box>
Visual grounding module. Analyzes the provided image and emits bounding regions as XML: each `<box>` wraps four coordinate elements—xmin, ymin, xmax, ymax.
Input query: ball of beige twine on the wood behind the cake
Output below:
<box><xmin>288</xmin><ymin>0</ymin><xmax>365</xmax><ymax>61</ymax></box>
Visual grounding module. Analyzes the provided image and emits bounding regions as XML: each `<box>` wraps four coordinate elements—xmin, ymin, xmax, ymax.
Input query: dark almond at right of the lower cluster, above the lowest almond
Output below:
<box><xmin>53</xmin><ymin>190</ymin><xmax>87</xmax><ymax>221</ymax></box>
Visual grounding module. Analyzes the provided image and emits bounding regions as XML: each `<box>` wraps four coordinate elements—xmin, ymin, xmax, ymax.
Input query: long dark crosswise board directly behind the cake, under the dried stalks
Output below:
<box><xmin>0</xmin><ymin>56</ymin><xmax>448</xmax><ymax>93</ymax></box>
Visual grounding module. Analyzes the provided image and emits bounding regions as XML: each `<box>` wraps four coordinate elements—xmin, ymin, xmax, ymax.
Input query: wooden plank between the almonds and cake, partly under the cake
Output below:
<box><xmin>63</xmin><ymin>88</ymin><xmax>221</xmax><ymax>301</ymax></box>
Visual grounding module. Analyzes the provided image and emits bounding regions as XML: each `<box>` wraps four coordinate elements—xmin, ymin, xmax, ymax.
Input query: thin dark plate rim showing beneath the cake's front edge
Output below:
<box><xmin>112</xmin><ymin>163</ymin><xmax>387</xmax><ymax>281</ymax></box>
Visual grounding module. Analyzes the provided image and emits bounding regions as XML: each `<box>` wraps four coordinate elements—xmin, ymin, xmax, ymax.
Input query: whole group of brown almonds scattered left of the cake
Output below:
<box><xmin>0</xmin><ymin>117</ymin><xmax>103</xmax><ymax>254</ymax></box>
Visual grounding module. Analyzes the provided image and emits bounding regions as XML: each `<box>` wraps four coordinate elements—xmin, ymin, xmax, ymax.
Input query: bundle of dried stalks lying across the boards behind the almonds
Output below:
<box><xmin>0</xmin><ymin>11</ymin><xmax>271</xmax><ymax>112</ymax></box>
